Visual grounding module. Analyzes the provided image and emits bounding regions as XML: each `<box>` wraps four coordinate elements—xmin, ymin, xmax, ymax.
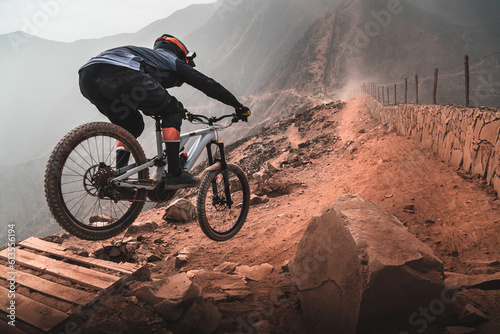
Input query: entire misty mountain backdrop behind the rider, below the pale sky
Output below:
<box><xmin>0</xmin><ymin>0</ymin><xmax>500</xmax><ymax>245</ymax></box>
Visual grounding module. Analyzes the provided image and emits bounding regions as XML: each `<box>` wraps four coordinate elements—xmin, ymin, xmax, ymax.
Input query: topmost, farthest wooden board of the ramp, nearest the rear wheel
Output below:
<box><xmin>19</xmin><ymin>237</ymin><xmax>139</xmax><ymax>275</ymax></box>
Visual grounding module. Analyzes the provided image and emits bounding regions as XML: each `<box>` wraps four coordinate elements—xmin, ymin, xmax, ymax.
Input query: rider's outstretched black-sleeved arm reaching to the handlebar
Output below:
<box><xmin>176</xmin><ymin>60</ymin><xmax>243</xmax><ymax>108</ymax></box>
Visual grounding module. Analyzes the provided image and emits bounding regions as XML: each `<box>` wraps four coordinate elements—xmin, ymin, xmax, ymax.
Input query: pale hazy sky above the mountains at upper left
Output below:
<box><xmin>0</xmin><ymin>0</ymin><xmax>216</xmax><ymax>42</ymax></box>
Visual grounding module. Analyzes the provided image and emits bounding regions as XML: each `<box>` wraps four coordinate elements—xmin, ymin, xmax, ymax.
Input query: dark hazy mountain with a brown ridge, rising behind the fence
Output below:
<box><xmin>257</xmin><ymin>0</ymin><xmax>500</xmax><ymax>106</ymax></box>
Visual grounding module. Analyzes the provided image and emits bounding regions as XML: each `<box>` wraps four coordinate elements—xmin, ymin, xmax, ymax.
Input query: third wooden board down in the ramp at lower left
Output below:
<box><xmin>0</xmin><ymin>266</ymin><xmax>97</xmax><ymax>305</ymax></box>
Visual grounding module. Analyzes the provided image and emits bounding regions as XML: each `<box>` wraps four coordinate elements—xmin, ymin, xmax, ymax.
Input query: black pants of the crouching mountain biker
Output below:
<box><xmin>80</xmin><ymin>64</ymin><xmax>183</xmax><ymax>138</ymax></box>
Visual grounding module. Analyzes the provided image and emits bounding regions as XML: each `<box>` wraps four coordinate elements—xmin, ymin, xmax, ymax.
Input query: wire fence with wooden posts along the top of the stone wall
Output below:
<box><xmin>353</xmin><ymin>52</ymin><xmax>500</xmax><ymax>108</ymax></box>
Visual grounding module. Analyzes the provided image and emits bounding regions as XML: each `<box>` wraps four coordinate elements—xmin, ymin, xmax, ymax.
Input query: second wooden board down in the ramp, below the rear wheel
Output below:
<box><xmin>0</xmin><ymin>249</ymin><xmax>120</xmax><ymax>290</ymax></box>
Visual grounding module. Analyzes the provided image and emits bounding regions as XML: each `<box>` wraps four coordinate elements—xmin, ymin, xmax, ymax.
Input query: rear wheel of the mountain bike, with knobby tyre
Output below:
<box><xmin>45</xmin><ymin>122</ymin><xmax>148</xmax><ymax>240</ymax></box>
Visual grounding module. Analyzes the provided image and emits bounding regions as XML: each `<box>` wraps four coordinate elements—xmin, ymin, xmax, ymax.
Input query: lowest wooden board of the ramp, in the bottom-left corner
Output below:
<box><xmin>0</xmin><ymin>287</ymin><xmax>68</xmax><ymax>332</ymax></box>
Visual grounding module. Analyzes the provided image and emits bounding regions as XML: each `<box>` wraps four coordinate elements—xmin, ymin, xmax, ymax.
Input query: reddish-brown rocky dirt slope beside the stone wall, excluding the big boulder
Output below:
<box><xmin>33</xmin><ymin>98</ymin><xmax>500</xmax><ymax>334</ymax></box>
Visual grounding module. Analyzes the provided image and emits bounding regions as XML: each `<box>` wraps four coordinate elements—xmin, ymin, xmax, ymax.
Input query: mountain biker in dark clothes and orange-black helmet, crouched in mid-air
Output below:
<box><xmin>78</xmin><ymin>34</ymin><xmax>251</xmax><ymax>189</ymax></box>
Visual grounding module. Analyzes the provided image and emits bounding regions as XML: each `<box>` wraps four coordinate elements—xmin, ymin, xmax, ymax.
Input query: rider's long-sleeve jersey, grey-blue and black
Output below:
<box><xmin>81</xmin><ymin>46</ymin><xmax>242</xmax><ymax>108</ymax></box>
